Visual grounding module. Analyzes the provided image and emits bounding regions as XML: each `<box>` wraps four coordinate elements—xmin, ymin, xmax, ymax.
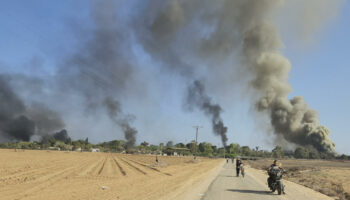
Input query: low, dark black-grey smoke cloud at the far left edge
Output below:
<box><xmin>0</xmin><ymin>75</ymin><xmax>64</xmax><ymax>142</ymax></box>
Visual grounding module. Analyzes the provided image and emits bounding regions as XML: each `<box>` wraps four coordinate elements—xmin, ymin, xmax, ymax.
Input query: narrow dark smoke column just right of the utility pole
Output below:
<box><xmin>186</xmin><ymin>80</ymin><xmax>227</xmax><ymax>146</ymax></box>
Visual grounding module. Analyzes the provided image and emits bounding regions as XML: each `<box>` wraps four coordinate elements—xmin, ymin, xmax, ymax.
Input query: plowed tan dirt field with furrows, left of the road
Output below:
<box><xmin>0</xmin><ymin>150</ymin><xmax>222</xmax><ymax>200</ymax></box>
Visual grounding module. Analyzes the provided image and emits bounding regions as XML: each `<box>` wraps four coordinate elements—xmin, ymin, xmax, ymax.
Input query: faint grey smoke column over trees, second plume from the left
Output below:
<box><xmin>104</xmin><ymin>97</ymin><xmax>137</xmax><ymax>148</ymax></box>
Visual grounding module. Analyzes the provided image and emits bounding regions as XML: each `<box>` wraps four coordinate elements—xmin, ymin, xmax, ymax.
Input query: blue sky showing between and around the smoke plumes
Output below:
<box><xmin>0</xmin><ymin>0</ymin><xmax>350</xmax><ymax>154</ymax></box>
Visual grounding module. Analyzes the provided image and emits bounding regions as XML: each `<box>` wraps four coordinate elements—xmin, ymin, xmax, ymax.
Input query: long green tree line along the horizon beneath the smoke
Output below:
<box><xmin>0</xmin><ymin>137</ymin><xmax>350</xmax><ymax>160</ymax></box>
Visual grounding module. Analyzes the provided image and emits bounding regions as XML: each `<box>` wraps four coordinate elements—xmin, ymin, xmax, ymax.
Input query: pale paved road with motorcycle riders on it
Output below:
<box><xmin>202</xmin><ymin>162</ymin><xmax>330</xmax><ymax>200</ymax></box>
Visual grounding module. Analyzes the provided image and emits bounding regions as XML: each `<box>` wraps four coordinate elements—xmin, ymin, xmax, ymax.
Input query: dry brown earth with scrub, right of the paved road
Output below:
<box><xmin>245</xmin><ymin>159</ymin><xmax>350</xmax><ymax>200</ymax></box>
